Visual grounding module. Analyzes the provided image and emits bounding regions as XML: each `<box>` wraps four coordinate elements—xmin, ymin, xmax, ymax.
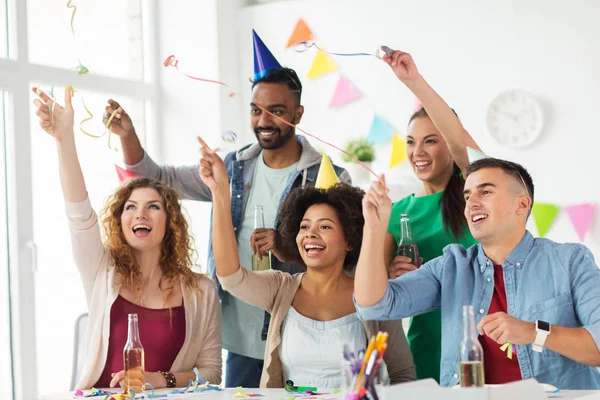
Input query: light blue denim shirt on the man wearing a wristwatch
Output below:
<box><xmin>356</xmin><ymin>232</ymin><xmax>600</xmax><ymax>389</ymax></box>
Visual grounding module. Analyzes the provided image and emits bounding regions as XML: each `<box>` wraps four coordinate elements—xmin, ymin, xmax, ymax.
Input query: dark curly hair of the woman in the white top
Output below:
<box><xmin>277</xmin><ymin>183</ymin><xmax>365</xmax><ymax>270</ymax></box>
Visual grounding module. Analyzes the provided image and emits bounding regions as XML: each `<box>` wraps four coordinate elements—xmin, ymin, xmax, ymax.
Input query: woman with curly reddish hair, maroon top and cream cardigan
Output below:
<box><xmin>34</xmin><ymin>88</ymin><xmax>221</xmax><ymax>391</ymax></box>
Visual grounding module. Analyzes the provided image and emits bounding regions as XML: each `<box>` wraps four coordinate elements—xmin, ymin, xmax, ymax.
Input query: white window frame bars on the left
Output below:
<box><xmin>0</xmin><ymin>0</ymin><xmax>163</xmax><ymax>400</ymax></box>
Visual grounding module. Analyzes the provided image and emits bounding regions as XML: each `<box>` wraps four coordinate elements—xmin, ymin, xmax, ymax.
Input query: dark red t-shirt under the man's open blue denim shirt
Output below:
<box><xmin>479</xmin><ymin>265</ymin><xmax>522</xmax><ymax>384</ymax></box>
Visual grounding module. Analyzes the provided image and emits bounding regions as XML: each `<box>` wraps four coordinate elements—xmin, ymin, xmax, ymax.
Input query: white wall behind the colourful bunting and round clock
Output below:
<box><xmin>219</xmin><ymin>0</ymin><xmax>600</xmax><ymax>256</ymax></box>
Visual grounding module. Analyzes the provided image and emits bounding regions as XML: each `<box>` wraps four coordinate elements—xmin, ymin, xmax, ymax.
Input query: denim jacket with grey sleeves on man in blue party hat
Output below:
<box><xmin>126</xmin><ymin>135</ymin><xmax>352</xmax><ymax>340</ymax></box>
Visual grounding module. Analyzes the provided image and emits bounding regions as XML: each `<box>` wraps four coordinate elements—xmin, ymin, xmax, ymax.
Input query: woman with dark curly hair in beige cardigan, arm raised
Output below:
<box><xmin>200</xmin><ymin>140</ymin><xmax>415</xmax><ymax>388</ymax></box>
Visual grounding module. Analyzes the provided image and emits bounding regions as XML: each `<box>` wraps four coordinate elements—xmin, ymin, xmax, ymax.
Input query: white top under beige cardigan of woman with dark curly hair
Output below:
<box><xmin>279</xmin><ymin>307</ymin><xmax>367</xmax><ymax>390</ymax></box>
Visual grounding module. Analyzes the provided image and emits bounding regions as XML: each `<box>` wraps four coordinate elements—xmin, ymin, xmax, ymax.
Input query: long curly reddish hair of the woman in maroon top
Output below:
<box><xmin>102</xmin><ymin>178</ymin><xmax>198</xmax><ymax>288</ymax></box>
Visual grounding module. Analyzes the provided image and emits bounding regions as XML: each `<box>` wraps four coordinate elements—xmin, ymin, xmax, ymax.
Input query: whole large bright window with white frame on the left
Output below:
<box><xmin>0</xmin><ymin>0</ymin><xmax>160</xmax><ymax>400</ymax></box>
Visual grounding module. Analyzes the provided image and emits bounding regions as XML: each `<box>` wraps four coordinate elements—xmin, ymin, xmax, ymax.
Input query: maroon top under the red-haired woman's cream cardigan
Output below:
<box><xmin>94</xmin><ymin>295</ymin><xmax>185</xmax><ymax>388</ymax></box>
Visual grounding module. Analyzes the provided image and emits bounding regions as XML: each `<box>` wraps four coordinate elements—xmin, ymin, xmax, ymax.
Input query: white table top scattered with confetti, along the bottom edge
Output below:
<box><xmin>40</xmin><ymin>389</ymin><xmax>600</xmax><ymax>400</ymax></box>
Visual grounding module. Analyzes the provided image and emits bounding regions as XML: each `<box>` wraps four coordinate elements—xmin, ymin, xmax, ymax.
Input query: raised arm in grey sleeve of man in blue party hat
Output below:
<box><xmin>103</xmin><ymin>99</ymin><xmax>211</xmax><ymax>201</ymax></box>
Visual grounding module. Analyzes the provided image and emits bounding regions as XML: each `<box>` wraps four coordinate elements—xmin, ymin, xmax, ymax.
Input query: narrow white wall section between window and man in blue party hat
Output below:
<box><xmin>158</xmin><ymin>0</ymin><xmax>222</xmax><ymax>267</ymax></box>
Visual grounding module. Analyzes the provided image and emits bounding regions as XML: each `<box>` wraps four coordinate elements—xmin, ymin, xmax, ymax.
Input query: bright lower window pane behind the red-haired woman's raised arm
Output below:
<box><xmin>29</xmin><ymin>84</ymin><xmax>145</xmax><ymax>394</ymax></box>
